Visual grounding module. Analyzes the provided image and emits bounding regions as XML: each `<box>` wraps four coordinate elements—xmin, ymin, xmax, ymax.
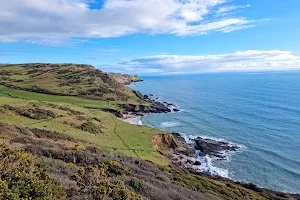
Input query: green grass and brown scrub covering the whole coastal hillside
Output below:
<box><xmin>0</xmin><ymin>65</ymin><xmax>297</xmax><ymax>200</ymax></box>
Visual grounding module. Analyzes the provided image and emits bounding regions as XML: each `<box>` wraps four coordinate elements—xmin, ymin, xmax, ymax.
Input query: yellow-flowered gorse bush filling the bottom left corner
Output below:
<box><xmin>0</xmin><ymin>145</ymin><xmax>65</xmax><ymax>200</ymax></box>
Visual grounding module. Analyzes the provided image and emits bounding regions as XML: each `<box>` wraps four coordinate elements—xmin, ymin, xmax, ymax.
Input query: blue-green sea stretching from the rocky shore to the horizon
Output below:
<box><xmin>130</xmin><ymin>72</ymin><xmax>300</xmax><ymax>194</ymax></box>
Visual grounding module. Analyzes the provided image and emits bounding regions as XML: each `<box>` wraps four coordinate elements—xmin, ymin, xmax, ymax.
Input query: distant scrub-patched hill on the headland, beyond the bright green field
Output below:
<box><xmin>0</xmin><ymin>64</ymin><xmax>141</xmax><ymax>103</ymax></box>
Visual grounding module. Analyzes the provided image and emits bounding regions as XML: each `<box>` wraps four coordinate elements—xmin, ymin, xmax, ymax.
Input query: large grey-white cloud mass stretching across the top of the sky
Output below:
<box><xmin>0</xmin><ymin>0</ymin><xmax>259</xmax><ymax>45</ymax></box>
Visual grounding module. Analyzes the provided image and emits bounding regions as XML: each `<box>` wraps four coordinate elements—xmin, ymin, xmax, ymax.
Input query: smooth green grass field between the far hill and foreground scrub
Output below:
<box><xmin>0</xmin><ymin>86</ymin><xmax>168</xmax><ymax>165</ymax></box>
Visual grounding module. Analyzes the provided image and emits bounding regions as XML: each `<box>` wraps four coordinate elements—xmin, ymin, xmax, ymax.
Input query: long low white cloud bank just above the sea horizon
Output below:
<box><xmin>111</xmin><ymin>50</ymin><xmax>300</xmax><ymax>74</ymax></box>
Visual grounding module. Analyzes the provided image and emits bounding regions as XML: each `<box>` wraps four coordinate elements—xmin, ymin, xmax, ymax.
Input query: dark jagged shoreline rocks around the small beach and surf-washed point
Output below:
<box><xmin>117</xmin><ymin>94</ymin><xmax>241</xmax><ymax>175</ymax></box>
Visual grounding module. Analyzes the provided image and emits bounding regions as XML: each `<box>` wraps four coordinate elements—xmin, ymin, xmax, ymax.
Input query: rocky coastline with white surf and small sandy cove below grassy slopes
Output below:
<box><xmin>118</xmin><ymin>88</ymin><xmax>243</xmax><ymax>179</ymax></box>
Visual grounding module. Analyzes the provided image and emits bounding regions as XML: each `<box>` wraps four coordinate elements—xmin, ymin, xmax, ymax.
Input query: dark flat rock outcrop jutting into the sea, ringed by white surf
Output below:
<box><xmin>194</xmin><ymin>137</ymin><xmax>240</xmax><ymax>158</ymax></box>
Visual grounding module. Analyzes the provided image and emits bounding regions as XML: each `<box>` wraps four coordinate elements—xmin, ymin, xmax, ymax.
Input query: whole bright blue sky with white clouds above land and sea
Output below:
<box><xmin>0</xmin><ymin>0</ymin><xmax>300</xmax><ymax>74</ymax></box>
